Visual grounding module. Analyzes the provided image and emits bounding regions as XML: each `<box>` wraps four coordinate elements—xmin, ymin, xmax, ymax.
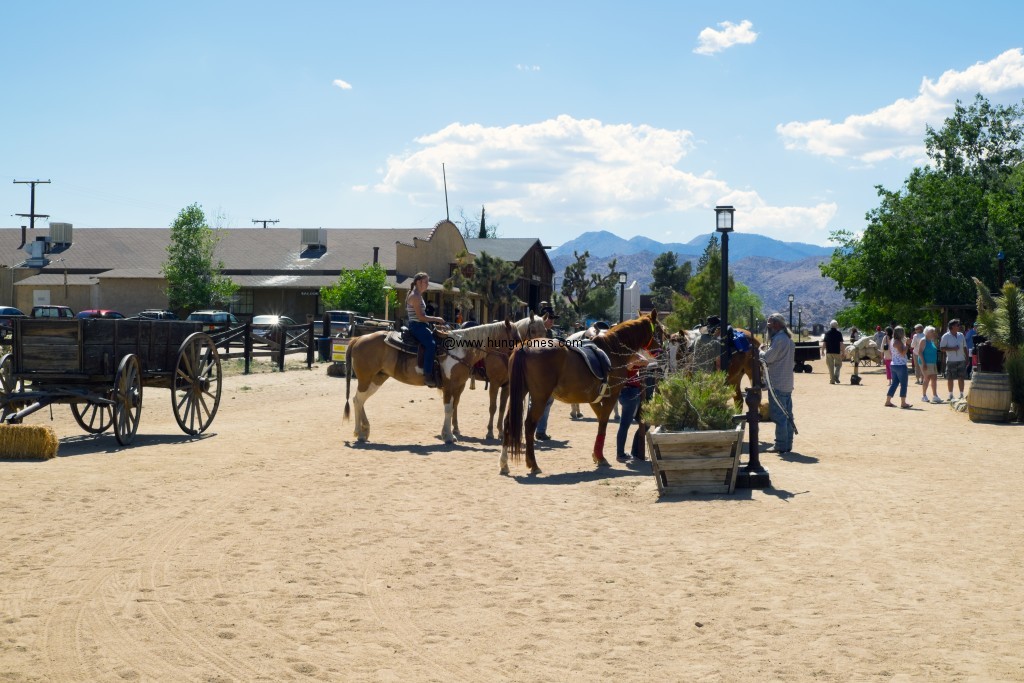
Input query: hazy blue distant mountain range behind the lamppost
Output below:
<box><xmin>548</xmin><ymin>230</ymin><xmax>849</xmax><ymax>328</ymax></box>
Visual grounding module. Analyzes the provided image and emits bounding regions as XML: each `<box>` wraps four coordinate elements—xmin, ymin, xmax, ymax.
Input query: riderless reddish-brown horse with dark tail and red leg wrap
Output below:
<box><xmin>501</xmin><ymin>311</ymin><xmax>665</xmax><ymax>474</ymax></box>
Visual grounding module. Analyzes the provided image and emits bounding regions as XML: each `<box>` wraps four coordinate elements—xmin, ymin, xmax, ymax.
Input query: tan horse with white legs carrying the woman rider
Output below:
<box><xmin>344</xmin><ymin>319</ymin><xmax>520</xmax><ymax>443</ymax></box>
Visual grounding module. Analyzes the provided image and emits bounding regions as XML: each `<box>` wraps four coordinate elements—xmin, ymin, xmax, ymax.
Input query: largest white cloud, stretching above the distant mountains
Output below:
<box><xmin>364</xmin><ymin>115</ymin><xmax>837</xmax><ymax>241</ymax></box>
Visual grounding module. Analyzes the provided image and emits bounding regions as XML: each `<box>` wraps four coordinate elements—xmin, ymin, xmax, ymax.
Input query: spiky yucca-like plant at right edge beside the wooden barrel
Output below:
<box><xmin>973</xmin><ymin>278</ymin><xmax>1024</xmax><ymax>420</ymax></box>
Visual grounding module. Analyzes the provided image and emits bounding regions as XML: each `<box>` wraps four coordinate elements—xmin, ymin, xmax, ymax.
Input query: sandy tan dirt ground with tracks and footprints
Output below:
<box><xmin>0</xmin><ymin>356</ymin><xmax>1024</xmax><ymax>682</ymax></box>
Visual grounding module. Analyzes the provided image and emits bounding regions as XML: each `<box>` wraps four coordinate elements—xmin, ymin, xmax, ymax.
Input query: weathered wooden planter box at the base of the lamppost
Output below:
<box><xmin>647</xmin><ymin>422</ymin><xmax>746</xmax><ymax>496</ymax></box>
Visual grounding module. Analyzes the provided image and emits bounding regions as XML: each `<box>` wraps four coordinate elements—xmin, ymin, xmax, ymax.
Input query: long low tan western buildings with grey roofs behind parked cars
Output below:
<box><xmin>0</xmin><ymin>220</ymin><xmax>551</xmax><ymax>321</ymax></box>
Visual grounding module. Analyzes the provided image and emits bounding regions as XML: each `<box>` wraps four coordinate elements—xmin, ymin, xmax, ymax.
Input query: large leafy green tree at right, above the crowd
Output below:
<box><xmin>820</xmin><ymin>95</ymin><xmax>1024</xmax><ymax>325</ymax></box>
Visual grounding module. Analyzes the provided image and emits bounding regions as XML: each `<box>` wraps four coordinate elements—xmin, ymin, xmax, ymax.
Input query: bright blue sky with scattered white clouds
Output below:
<box><xmin>0</xmin><ymin>0</ymin><xmax>1024</xmax><ymax>245</ymax></box>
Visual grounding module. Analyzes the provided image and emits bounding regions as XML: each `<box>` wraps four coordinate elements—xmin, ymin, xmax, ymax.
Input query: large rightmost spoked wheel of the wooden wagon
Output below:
<box><xmin>171</xmin><ymin>332</ymin><xmax>221</xmax><ymax>436</ymax></box>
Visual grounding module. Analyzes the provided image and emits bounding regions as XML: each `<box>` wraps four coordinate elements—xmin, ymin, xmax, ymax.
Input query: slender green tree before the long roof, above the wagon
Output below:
<box><xmin>161</xmin><ymin>204</ymin><xmax>239</xmax><ymax>311</ymax></box>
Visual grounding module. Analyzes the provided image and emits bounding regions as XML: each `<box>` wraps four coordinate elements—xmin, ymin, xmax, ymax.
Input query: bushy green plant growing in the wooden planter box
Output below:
<box><xmin>643</xmin><ymin>372</ymin><xmax>735</xmax><ymax>431</ymax></box>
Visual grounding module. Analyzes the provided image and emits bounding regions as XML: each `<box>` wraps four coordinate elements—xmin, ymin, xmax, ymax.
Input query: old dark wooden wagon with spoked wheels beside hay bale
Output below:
<box><xmin>0</xmin><ymin>318</ymin><xmax>222</xmax><ymax>445</ymax></box>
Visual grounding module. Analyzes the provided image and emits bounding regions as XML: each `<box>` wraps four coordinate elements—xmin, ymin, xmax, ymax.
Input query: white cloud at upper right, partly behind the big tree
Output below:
<box><xmin>775</xmin><ymin>48</ymin><xmax>1024</xmax><ymax>164</ymax></box>
